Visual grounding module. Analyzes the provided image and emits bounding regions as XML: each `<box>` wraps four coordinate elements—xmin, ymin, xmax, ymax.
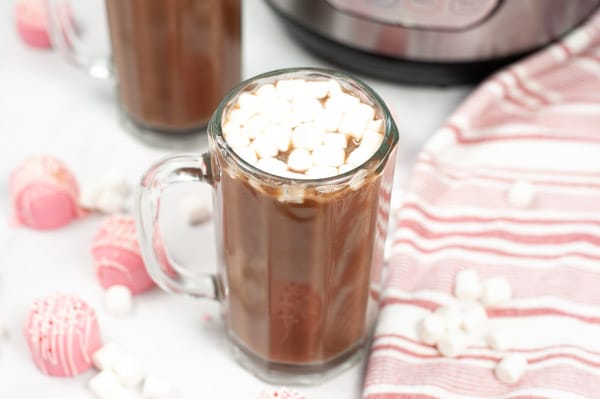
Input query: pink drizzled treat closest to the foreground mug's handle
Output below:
<box><xmin>92</xmin><ymin>215</ymin><xmax>154</xmax><ymax>294</ymax></box>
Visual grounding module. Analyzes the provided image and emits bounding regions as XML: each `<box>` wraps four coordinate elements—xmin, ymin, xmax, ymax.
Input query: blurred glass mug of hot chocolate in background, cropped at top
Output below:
<box><xmin>48</xmin><ymin>0</ymin><xmax>241</xmax><ymax>144</ymax></box>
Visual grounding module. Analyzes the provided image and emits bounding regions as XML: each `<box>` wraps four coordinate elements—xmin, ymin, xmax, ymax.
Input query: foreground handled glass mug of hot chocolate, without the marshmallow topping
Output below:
<box><xmin>136</xmin><ymin>69</ymin><xmax>398</xmax><ymax>384</ymax></box>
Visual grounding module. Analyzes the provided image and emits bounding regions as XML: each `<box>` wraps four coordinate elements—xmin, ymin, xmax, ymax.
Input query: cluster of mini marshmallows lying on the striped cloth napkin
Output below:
<box><xmin>418</xmin><ymin>270</ymin><xmax>527</xmax><ymax>384</ymax></box>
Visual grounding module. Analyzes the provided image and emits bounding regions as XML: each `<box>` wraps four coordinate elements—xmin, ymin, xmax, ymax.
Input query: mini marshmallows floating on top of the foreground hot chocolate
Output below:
<box><xmin>223</xmin><ymin>79</ymin><xmax>384</xmax><ymax>179</ymax></box>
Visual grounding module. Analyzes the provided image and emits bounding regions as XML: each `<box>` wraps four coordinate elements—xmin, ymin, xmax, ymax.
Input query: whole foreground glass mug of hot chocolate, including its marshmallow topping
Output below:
<box><xmin>136</xmin><ymin>69</ymin><xmax>398</xmax><ymax>383</ymax></box>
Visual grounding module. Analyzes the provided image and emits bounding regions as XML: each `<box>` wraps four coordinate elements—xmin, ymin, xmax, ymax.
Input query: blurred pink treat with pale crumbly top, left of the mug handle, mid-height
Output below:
<box><xmin>10</xmin><ymin>156</ymin><xmax>84</xmax><ymax>230</ymax></box>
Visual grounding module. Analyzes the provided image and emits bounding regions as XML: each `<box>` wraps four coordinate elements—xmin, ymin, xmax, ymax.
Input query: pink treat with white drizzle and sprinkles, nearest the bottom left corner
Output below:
<box><xmin>25</xmin><ymin>295</ymin><xmax>101</xmax><ymax>377</ymax></box>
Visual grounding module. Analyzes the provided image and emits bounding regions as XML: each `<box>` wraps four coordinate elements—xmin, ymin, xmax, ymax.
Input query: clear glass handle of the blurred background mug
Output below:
<box><xmin>46</xmin><ymin>0</ymin><xmax>114</xmax><ymax>79</ymax></box>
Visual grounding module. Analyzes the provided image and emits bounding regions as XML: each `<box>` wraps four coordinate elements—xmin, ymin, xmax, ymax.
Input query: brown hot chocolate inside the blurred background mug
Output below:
<box><xmin>107</xmin><ymin>0</ymin><xmax>241</xmax><ymax>132</ymax></box>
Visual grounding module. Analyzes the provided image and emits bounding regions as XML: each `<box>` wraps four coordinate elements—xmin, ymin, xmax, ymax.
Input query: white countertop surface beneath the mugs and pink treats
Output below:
<box><xmin>0</xmin><ymin>0</ymin><xmax>468</xmax><ymax>399</ymax></box>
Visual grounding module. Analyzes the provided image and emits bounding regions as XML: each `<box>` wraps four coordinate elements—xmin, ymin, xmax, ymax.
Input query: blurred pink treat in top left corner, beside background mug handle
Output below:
<box><xmin>15</xmin><ymin>0</ymin><xmax>52</xmax><ymax>48</ymax></box>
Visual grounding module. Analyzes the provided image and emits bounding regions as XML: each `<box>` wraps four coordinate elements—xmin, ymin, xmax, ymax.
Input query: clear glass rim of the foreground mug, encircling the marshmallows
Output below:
<box><xmin>207</xmin><ymin>67</ymin><xmax>399</xmax><ymax>188</ymax></box>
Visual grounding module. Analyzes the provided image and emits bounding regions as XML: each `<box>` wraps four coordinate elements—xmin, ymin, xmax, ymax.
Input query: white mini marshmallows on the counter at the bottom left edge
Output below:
<box><xmin>88</xmin><ymin>343</ymin><xmax>178</xmax><ymax>399</ymax></box>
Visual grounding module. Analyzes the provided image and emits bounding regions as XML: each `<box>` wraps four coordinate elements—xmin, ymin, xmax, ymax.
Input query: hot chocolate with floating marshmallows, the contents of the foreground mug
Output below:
<box><xmin>214</xmin><ymin>76</ymin><xmax>391</xmax><ymax>366</ymax></box>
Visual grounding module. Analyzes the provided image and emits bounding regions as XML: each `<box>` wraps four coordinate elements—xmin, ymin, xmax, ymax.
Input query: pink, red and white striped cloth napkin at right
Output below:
<box><xmin>364</xmin><ymin>10</ymin><xmax>600</xmax><ymax>399</ymax></box>
